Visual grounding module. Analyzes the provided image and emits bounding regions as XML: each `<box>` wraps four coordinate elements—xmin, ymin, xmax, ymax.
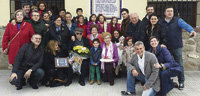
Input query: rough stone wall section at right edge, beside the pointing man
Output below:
<box><xmin>182</xmin><ymin>29</ymin><xmax>200</xmax><ymax>71</ymax></box>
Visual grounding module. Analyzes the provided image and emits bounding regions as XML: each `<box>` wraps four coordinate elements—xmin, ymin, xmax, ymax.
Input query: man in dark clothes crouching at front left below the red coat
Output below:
<box><xmin>9</xmin><ymin>34</ymin><xmax>44</xmax><ymax>90</ymax></box>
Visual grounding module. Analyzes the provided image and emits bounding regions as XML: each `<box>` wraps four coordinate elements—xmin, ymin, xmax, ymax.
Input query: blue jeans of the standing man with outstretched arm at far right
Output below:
<box><xmin>169</xmin><ymin>48</ymin><xmax>185</xmax><ymax>83</ymax></box>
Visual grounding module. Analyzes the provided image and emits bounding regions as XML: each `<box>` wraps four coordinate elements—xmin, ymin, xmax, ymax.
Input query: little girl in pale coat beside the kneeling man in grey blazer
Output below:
<box><xmin>123</xmin><ymin>37</ymin><xmax>135</xmax><ymax>66</ymax></box>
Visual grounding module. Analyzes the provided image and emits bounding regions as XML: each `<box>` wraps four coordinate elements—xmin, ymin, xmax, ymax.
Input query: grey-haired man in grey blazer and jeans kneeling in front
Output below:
<box><xmin>121</xmin><ymin>41</ymin><xmax>160</xmax><ymax>96</ymax></box>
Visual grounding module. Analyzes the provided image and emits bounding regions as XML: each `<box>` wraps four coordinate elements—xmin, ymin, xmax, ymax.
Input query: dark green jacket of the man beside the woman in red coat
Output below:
<box><xmin>27</xmin><ymin>19</ymin><xmax>47</xmax><ymax>46</ymax></box>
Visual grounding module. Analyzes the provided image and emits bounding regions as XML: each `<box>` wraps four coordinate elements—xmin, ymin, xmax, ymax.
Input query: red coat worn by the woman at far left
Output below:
<box><xmin>2</xmin><ymin>21</ymin><xmax>34</xmax><ymax>64</ymax></box>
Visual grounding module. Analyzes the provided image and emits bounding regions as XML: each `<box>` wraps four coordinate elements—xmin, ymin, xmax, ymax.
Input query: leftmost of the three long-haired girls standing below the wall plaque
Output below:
<box><xmin>87</xmin><ymin>14</ymin><xmax>102</xmax><ymax>34</ymax></box>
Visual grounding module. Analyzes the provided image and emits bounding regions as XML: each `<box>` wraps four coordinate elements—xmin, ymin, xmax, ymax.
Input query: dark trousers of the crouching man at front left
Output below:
<box><xmin>11</xmin><ymin>68</ymin><xmax>44</xmax><ymax>87</ymax></box>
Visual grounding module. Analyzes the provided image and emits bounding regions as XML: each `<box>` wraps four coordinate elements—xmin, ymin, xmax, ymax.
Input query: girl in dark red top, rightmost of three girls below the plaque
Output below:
<box><xmin>107</xmin><ymin>17</ymin><xmax>121</xmax><ymax>34</ymax></box>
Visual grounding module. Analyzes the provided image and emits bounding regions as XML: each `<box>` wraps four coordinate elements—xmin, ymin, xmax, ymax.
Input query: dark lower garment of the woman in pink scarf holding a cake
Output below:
<box><xmin>103</xmin><ymin>63</ymin><xmax>114</xmax><ymax>83</ymax></box>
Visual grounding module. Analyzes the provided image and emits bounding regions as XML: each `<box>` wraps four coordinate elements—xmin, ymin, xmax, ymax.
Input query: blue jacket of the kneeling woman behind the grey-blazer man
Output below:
<box><xmin>149</xmin><ymin>45</ymin><xmax>181</xmax><ymax>72</ymax></box>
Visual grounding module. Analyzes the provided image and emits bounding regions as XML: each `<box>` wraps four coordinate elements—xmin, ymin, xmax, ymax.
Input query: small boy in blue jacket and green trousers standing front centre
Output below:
<box><xmin>90</xmin><ymin>38</ymin><xmax>102</xmax><ymax>85</ymax></box>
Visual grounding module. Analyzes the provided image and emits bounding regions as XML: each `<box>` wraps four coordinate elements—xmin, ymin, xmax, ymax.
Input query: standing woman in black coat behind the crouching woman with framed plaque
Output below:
<box><xmin>49</xmin><ymin>16</ymin><xmax>71</xmax><ymax>56</ymax></box>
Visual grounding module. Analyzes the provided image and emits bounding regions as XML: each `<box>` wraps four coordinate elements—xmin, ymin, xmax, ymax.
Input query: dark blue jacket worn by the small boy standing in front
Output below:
<box><xmin>90</xmin><ymin>46</ymin><xmax>102</xmax><ymax>65</ymax></box>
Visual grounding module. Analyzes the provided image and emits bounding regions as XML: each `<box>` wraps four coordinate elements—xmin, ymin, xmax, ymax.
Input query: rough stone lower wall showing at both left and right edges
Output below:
<box><xmin>0</xmin><ymin>26</ymin><xmax>200</xmax><ymax>71</ymax></box>
